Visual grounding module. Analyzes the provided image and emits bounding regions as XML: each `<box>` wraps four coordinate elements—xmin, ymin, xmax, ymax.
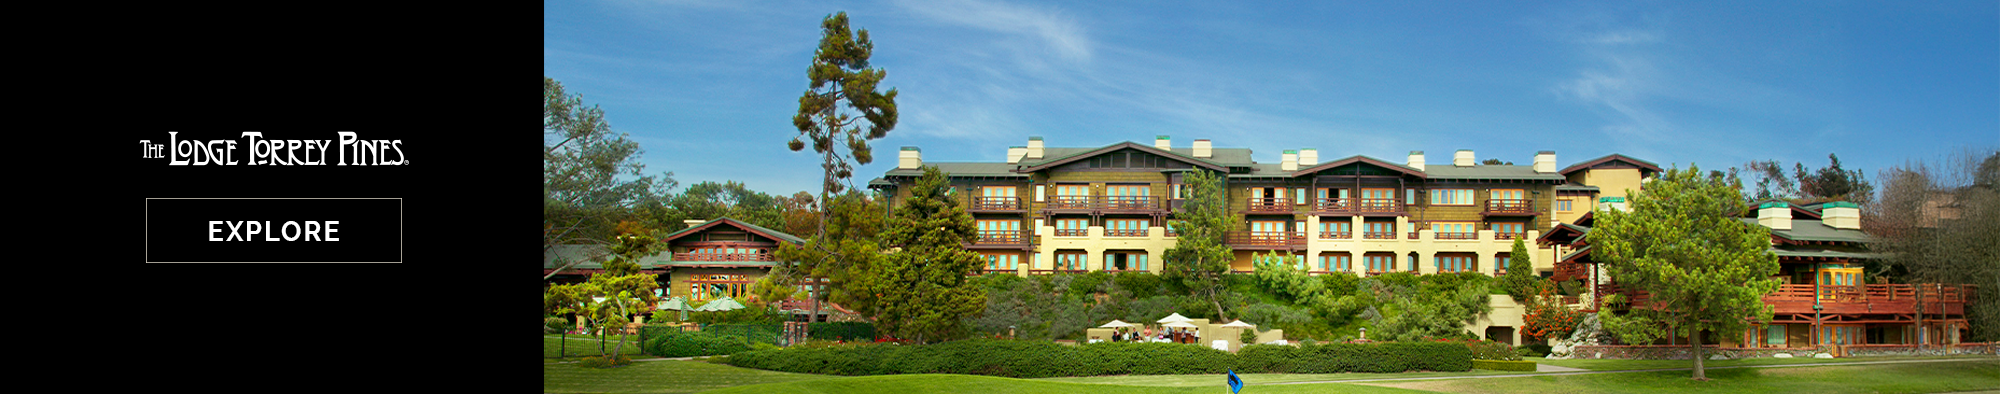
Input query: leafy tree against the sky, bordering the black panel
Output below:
<box><xmin>542</xmin><ymin>76</ymin><xmax>676</xmax><ymax>264</ymax></box>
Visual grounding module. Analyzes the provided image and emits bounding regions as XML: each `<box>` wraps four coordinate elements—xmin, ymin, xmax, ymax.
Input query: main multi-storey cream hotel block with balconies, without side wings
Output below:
<box><xmin>870</xmin><ymin>136</ymin><xmax>1660</xmax><ymax>274</ymax></box>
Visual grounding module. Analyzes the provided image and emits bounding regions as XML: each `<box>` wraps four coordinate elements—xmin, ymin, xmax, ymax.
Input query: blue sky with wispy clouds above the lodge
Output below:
<box><xmin>542</xmin><ymin>0</ymin><xmax>2000</xmax><ymax>194</ymax></box>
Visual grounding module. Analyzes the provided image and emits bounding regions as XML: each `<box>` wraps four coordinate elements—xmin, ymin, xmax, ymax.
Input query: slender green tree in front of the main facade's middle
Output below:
<box><xmin>1162</xmin><ymin>170</ymin><xmax>1236</xmax><ymax>320</ymax></box>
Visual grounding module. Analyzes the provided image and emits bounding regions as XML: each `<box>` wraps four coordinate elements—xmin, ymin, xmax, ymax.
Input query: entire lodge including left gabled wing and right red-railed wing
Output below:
<box><xmin>544</xmin><ymin>136</ymin><xmax>1972</xmax><ymax>348</ymax></box>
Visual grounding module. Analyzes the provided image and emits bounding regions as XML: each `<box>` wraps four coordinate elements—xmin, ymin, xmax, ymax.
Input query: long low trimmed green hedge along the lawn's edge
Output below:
<box><xmin>726</xmin><ymin>340</ymin><xmax>1472</xmax><ymax>378</ymax></box>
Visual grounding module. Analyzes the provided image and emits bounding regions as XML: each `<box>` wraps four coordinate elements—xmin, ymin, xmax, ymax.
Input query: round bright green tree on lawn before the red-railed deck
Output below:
<box><xmin>1588</xmin><ymin>166</ymin><xmax>1778</xmax><ymax>380</ymax></box>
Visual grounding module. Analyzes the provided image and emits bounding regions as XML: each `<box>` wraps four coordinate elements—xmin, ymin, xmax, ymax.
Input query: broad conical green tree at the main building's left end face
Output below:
<box><xmin>850</xmin><ymin>166</ymin><xmax>986</xmax><ymax>342</ymax></box>
